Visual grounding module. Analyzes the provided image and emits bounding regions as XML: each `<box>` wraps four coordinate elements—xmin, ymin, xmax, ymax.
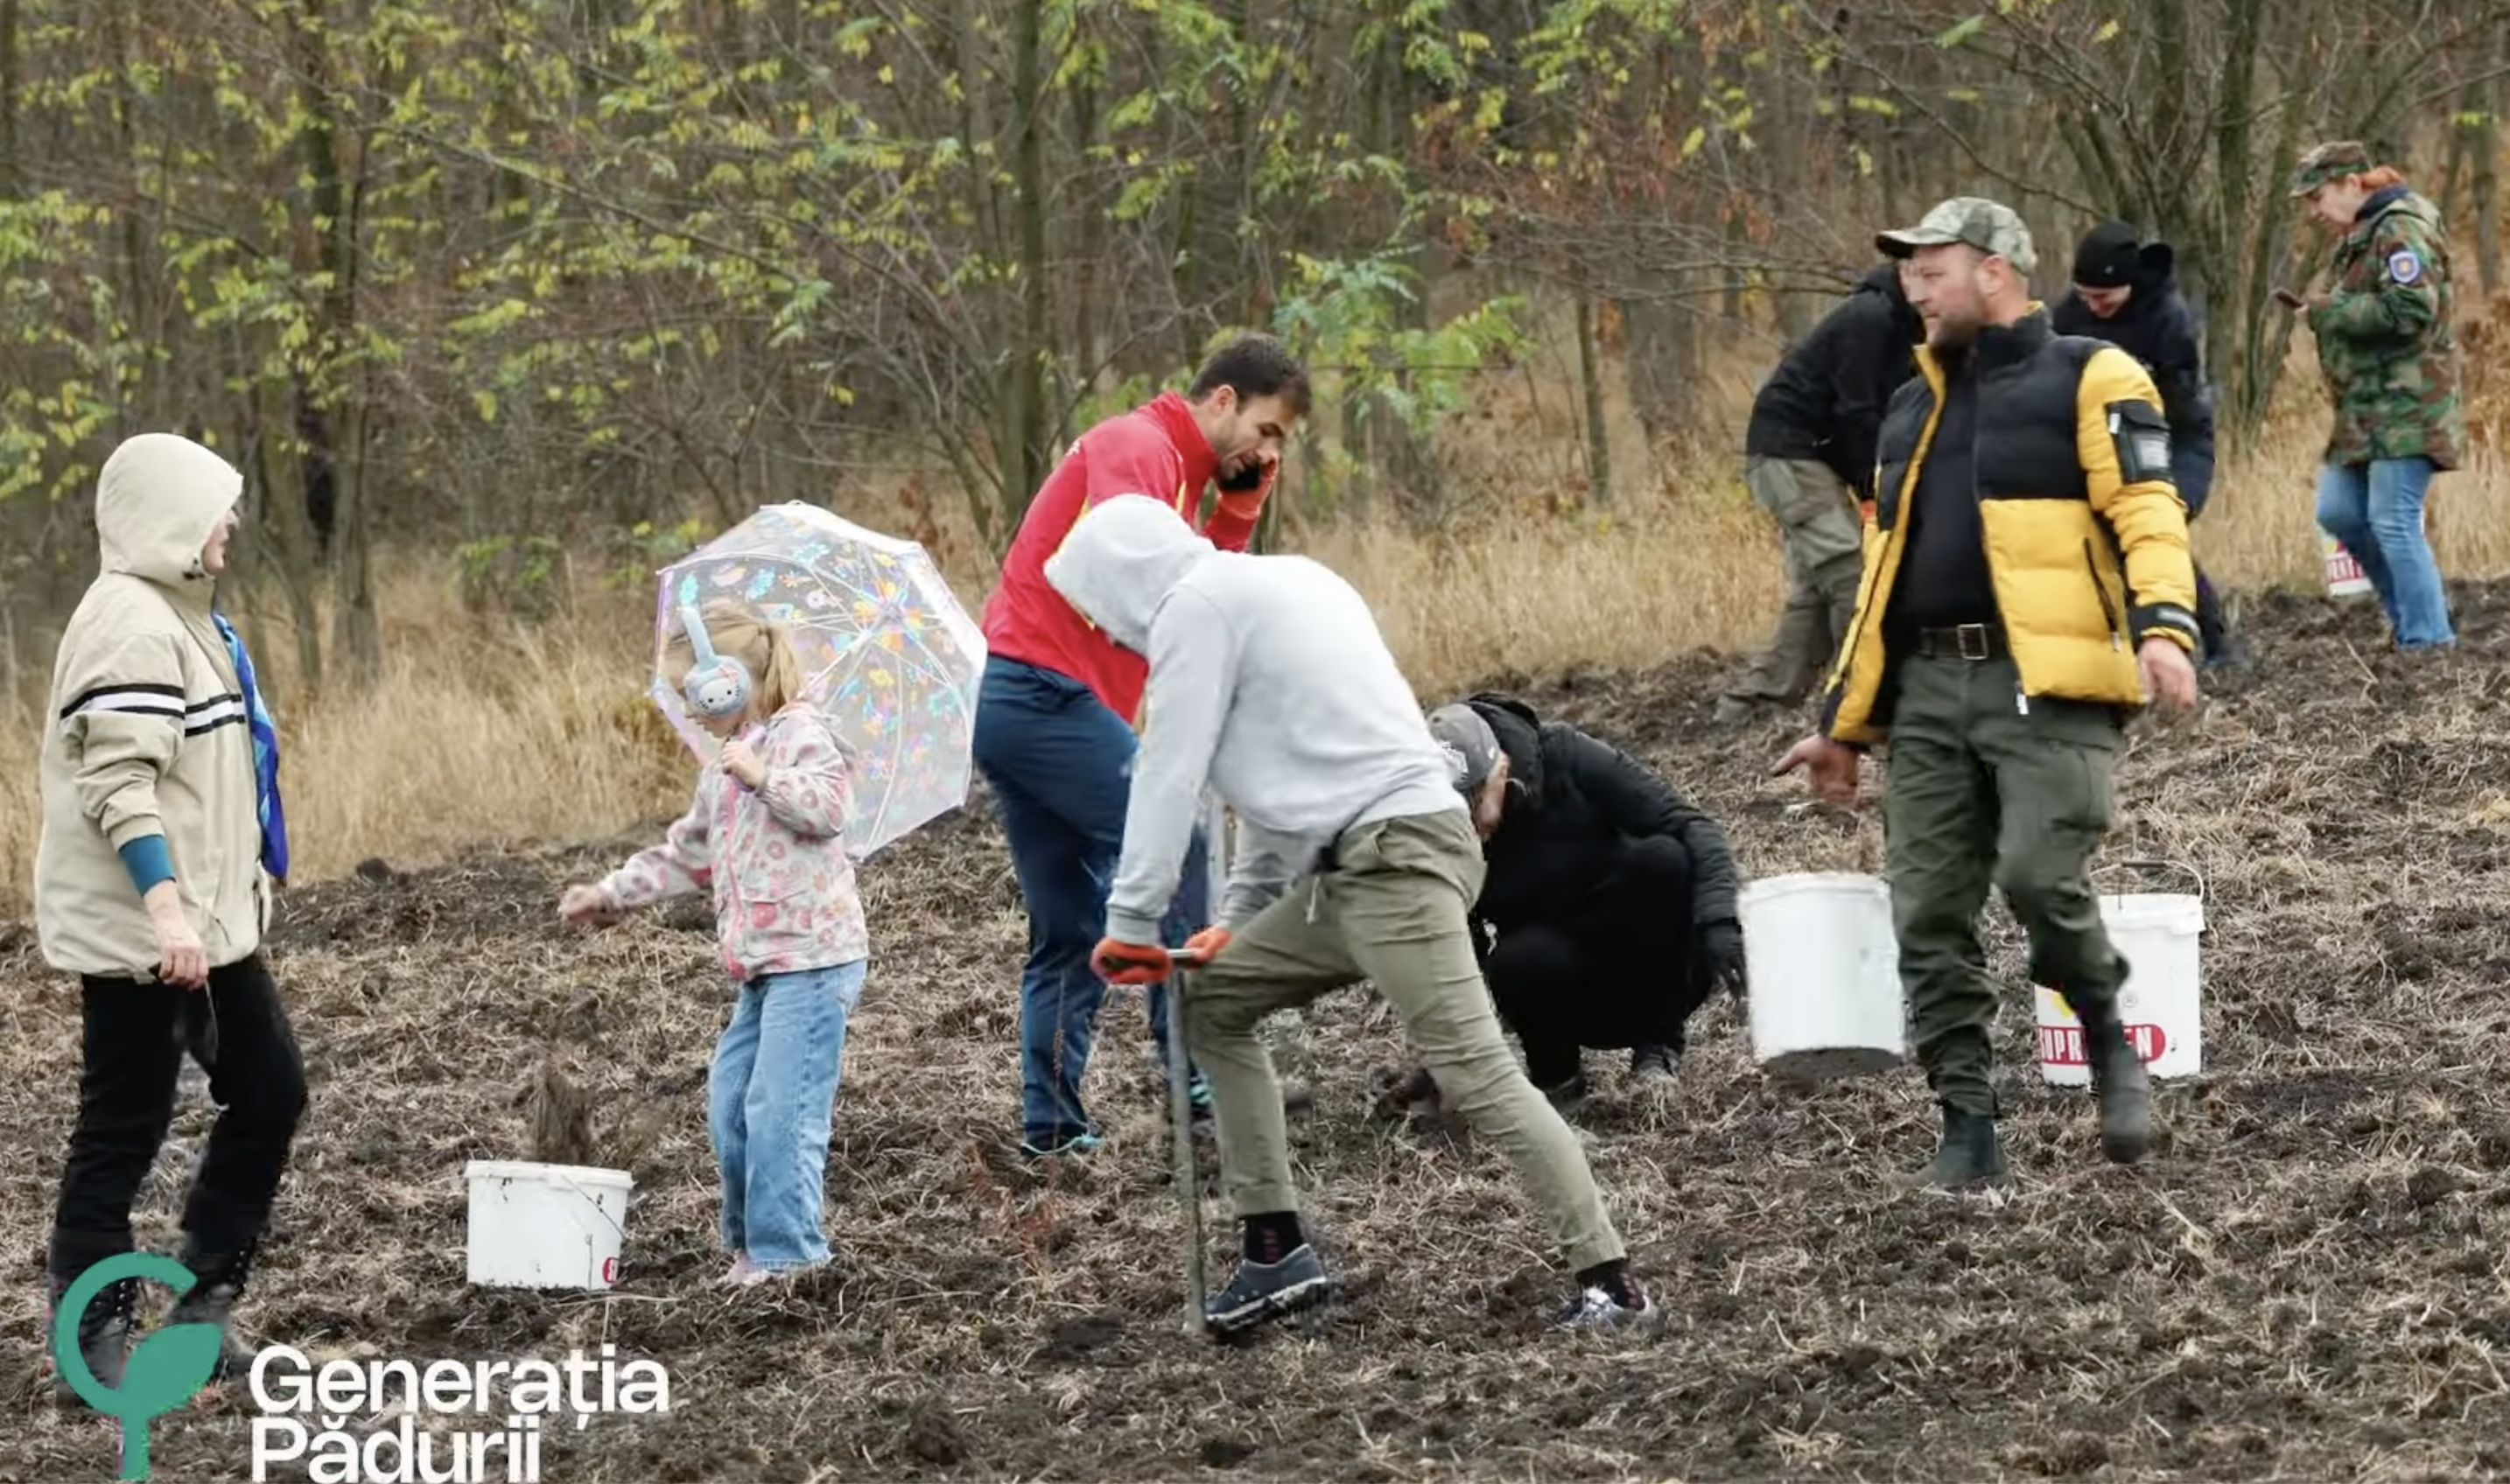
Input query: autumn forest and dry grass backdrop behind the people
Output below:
<box><xmin>0</xmin><ymin>0</ymin><xmax>2510</xmax><ymax>899</ymax></box>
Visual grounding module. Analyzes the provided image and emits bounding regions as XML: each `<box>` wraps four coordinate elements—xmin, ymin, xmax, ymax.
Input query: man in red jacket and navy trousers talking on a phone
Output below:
<box><xmin>974</xmin><ymin>334</ymin><xmax>1308</xmax><ymax>1155</ymax></box>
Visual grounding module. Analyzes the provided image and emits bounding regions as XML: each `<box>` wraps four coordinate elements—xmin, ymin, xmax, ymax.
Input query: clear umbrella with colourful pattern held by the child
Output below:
<box><xmin>648</xmin><ymin>500</ymin><xmax>984</xmax><ymax>857</ymax></box>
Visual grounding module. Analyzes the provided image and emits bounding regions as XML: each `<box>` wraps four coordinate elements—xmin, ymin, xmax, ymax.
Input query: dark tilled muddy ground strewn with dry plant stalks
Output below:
<box><xmin>0</xmin><ymin>588</ymin><xmax>2510</xmax><ymax>1484</ymax></box>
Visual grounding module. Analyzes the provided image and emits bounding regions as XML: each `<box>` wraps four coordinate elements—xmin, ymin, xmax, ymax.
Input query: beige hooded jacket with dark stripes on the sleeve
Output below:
<box><xmin>35</xmin><ymin>432</ymin><xmax>269</xmax><ymax>979</ymax></box>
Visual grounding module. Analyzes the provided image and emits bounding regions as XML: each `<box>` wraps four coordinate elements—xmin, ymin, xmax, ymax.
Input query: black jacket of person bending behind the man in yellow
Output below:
<box><xmin>1742</xmin><ymin>261</ymin><xmax>1925</xmax><ymax>500</ymax></box>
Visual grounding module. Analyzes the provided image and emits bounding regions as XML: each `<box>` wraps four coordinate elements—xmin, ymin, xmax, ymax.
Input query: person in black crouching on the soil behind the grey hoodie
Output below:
<box><xmin>1431</xmin><ymin>693</ymin><xmax>1744</xmax><ymax>1102</ymax></box>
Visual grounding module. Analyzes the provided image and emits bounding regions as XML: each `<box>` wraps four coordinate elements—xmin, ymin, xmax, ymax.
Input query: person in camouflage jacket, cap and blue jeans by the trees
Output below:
<box><xmin>2291</xmin><ymin>141</ymin><xmax>2467</xmax><ymax>650</ymax></box>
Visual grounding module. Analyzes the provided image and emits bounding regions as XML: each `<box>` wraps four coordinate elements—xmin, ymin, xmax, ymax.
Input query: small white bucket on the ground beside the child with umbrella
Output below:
<box><xmin>462</xmin><ymin>1160</ymin><xmax>635</xmax><ymax>1288</ymax></box>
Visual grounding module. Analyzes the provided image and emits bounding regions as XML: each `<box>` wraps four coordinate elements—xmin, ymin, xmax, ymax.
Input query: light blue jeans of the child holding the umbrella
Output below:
<box><xmin>705</xmin><ymin>959</ymin><xmax>866</xmax><ymax>1268</ymax></box>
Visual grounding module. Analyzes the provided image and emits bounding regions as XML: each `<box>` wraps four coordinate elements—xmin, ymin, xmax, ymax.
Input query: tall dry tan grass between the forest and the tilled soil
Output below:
<box><xmin>0</xmin><ymin>317</ymin><xmax>2510</xmax><ymax>901</ymax></box>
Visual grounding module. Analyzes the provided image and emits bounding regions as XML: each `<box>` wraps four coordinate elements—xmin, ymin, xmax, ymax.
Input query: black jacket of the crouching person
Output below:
<box><xmin>1466</xmin><ymin>693</ymin><xmax>1735</xmax><ymax>942</ymax></box>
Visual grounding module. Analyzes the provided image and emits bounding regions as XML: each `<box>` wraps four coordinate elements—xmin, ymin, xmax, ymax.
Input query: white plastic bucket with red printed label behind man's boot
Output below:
<box><xmin>2030</xmin><ymin>892</ymin><xmax>2204</xmax><ymax>1088</ymax></box>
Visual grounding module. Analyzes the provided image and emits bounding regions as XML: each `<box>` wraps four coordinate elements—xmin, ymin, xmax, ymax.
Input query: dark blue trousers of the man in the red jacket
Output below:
<box><xmin>971</xmin><ymin>655</ymin><xmax>1209</xmax><ymax>1150</ymax></box>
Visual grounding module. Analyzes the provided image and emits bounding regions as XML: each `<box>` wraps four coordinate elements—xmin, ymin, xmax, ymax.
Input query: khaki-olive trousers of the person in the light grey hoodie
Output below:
<box><xmin>1182</xmin><ymin>808</ymin><xmax>1624</xmax><ymax>1270</ymax></box>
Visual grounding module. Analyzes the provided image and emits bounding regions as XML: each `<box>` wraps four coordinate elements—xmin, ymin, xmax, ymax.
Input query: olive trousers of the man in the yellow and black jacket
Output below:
<box><xmin>1882</xmin><ymin>655</ymin><xmax>2126</xmax><ymax>1115</ymax></box>
